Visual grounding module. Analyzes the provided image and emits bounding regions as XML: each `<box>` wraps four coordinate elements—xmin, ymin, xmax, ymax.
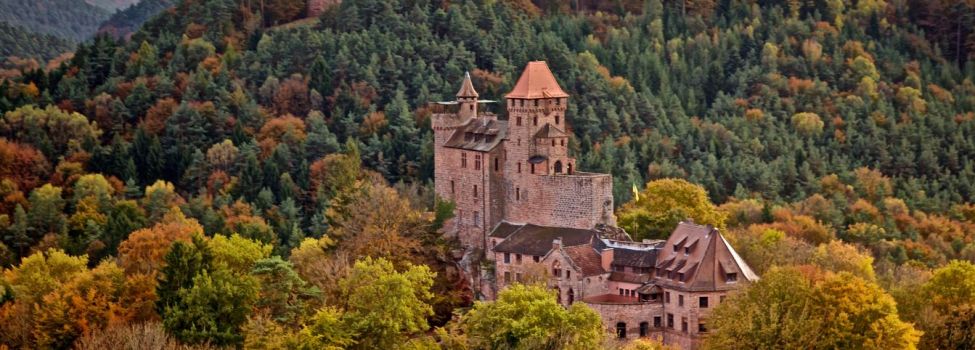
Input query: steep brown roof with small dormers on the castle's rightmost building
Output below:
<box><xmin>654</xmin><ymin>222</ymin><xmax>758</xmax><ymax>291</ymax></box>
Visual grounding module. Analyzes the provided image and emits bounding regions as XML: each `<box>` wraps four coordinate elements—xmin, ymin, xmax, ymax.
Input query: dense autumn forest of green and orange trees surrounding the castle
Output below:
<box><xmin>0</xmin><ymin>0</ymin><xmax>975</xmax><ymax>349</ymax></box>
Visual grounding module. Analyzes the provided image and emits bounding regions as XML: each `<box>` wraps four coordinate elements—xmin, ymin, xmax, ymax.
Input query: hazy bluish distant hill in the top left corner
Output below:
<box><xmin>0</xmin><ymin>0</ymin><xmax>111</xmax><ymax>41</ymax></box>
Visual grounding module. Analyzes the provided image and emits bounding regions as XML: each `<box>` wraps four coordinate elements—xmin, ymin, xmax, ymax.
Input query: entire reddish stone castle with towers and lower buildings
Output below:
<box><xmin>431</xmin><ymin>61</ymin><xmax>758</xmax><ymax>349</ymax></box>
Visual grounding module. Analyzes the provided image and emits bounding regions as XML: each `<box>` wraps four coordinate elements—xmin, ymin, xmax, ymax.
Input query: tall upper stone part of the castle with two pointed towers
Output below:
<box><xmin>431</xmin><ymin>61</ymin><xmax>616</xmax><ymax>254</ymax></box>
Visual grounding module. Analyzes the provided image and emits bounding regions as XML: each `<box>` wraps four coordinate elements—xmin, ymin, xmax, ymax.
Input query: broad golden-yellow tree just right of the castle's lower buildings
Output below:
<box><xmin>705</xmin><ymin>267</ymin><xmax>920</xmax><ymax>349</ymax></box>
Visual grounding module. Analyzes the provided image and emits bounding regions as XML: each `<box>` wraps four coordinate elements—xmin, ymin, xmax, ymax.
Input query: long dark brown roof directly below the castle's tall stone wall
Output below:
<box><xmin>491</xmin><ymin>224</ymin><xmax>599</xmax><ymax>256</ymax></box>
